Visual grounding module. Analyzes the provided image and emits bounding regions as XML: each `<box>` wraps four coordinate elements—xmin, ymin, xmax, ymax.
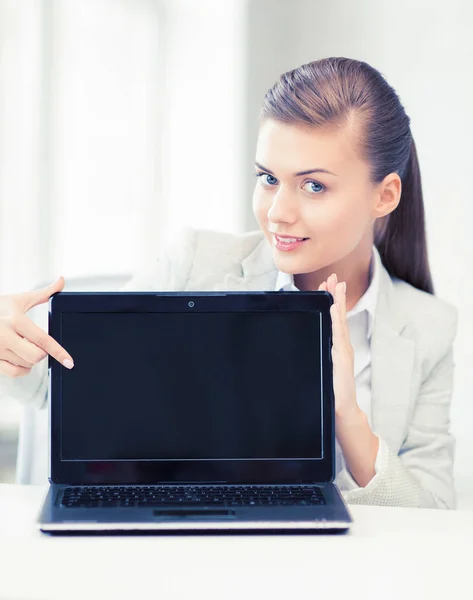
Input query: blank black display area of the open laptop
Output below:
<box><xmin>60</xmin><ymin>311</ymin><xmax>323</xmax><ymax>461</ymax></box>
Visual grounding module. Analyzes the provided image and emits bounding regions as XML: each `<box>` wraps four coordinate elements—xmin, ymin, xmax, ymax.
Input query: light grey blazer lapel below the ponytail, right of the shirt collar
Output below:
<box><xmin>371</xmin><ymin>265</ymin><xmax>415</xmax><ymax>453</ymax></box>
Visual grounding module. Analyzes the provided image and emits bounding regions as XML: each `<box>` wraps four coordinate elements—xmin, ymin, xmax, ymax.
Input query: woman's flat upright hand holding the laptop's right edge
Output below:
<box><xmin>319</xmin><ymin>273</ymin><xmax>360</xmax><ymax>417</ymax></box>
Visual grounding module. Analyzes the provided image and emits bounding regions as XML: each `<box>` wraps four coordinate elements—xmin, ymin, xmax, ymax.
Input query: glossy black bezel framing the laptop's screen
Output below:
<box><xmin>49</xmin><ymin>291</ymin><xmax>335</xmax><ymax>485</ymax></box>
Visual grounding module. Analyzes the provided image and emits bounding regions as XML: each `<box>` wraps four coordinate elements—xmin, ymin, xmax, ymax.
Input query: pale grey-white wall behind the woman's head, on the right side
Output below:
<box><xmin>246</xmin><ymin>0</ymin><xmax>473</xmax><ymax>500</ymax></box>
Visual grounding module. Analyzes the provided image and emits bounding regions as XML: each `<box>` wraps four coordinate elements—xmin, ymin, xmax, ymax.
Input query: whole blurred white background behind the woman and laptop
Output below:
<box><xmin>0</xmin><ymin>0</ymin><xmax>473</xmax><ymax>506</ymax></box>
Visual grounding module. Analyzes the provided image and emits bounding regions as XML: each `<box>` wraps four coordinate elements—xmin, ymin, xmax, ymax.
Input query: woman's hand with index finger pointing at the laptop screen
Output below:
<box><xmin>0</xmin><ymin>277</ymin><xmax>73</xmax><ymax>377</ymax></box>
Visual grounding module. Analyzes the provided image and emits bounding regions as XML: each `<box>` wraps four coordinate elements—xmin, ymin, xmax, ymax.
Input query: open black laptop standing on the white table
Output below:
<box><xmin>37</xmin><ymin>291</ymin><xmax>352</xmax><ymax>533</ymax></box>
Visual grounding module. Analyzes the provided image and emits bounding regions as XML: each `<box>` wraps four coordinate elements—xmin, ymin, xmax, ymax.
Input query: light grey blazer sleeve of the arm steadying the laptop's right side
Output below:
<box><xmin>336</xmin><ymin>309</ymin><xmax>458</xmax><ymax>509</ymax></box>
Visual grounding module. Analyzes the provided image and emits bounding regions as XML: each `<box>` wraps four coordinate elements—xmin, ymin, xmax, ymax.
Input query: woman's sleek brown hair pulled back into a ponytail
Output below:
<box><xmin>260</xmin><ymin>57</ymin><xmax>434</xmax><ymax>294</ymax></box>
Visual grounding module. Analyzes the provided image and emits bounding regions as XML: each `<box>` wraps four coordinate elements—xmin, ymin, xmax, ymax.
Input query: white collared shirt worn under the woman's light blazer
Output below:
<box><xmin>275</xmin><ymin>245</ymin><xmax>386</xmax><ymax>490</ymax></box>
